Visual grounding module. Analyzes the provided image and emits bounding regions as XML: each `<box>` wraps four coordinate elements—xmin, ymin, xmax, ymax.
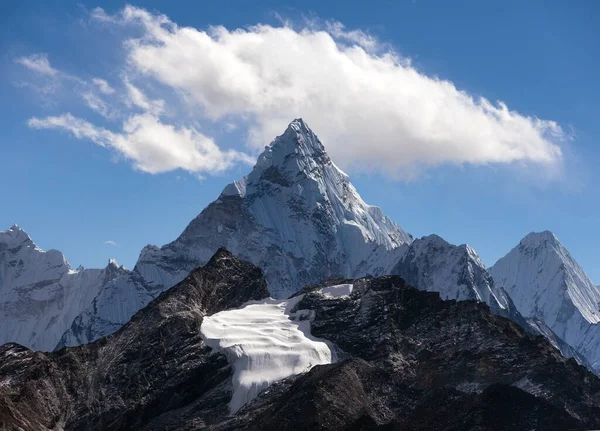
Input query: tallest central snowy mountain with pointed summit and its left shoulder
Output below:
<box><xmin>62</xmin><ymin>119</ymin><xmax>412</xmax><ymax>345</ymax></box>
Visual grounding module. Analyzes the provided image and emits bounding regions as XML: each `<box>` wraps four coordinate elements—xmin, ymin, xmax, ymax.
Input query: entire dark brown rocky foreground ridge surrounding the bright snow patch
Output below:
<box><xmin>0</xmin><ymin>250</ymin><xmax>600</xmax><ymax>431</ymax></box>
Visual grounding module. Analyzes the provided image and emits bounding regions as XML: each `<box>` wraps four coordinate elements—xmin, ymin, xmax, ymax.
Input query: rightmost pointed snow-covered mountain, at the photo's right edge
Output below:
<box><xmin>489</xmin><ymin>231</ymin><xmax>600</xmax><ymax>369</ymax></box>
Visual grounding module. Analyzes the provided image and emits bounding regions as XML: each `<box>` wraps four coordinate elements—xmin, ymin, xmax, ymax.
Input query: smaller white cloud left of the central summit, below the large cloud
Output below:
<box><xmin>28</xmin><ymin>113</ymin><xmax>251</xmax><ymax>174</ymax></box>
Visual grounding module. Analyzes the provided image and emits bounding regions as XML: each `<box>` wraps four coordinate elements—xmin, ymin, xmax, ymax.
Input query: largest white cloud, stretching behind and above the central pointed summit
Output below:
<box><xmin>97</xmin><ymin>6</ymin><xmax>563</xmax><ymax>175</ymax></box>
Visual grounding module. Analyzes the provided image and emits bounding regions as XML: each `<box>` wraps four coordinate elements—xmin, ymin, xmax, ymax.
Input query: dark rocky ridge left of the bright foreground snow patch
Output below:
<box><xmin>0</xmin><ymin>250</ymin><xmax>268</xmax><ymax>430</ymax></box>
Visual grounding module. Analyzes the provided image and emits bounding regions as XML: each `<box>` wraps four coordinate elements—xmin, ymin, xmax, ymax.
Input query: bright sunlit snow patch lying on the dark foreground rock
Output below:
<box><xmin>200</xmin><ymin>295</ymin><xmax>333</xmax><ymax>413</ymax></box>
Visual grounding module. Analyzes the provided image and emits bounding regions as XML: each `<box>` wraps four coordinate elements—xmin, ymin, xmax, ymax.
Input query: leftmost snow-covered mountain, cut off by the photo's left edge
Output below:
<box><xmin>0</xmin><ymin>225</ymin><xmax>125</xmax><ymax>350</ymax></box>
